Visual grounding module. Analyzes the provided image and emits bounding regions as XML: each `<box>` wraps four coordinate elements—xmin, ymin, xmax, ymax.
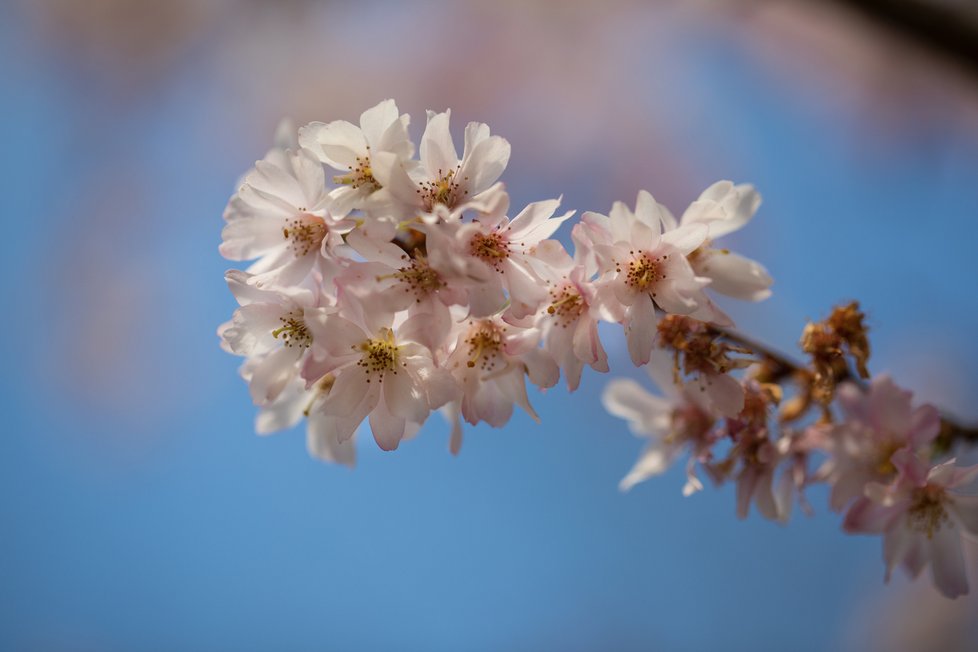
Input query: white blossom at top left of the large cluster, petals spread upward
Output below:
<box><xmin>299</xmin><ymin>100</ymin><xmax>414</xmax><ymax>217</ymax></box>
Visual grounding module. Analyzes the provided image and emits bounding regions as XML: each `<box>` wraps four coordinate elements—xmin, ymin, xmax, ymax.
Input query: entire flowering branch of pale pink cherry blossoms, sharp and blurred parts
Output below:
<box><xmin>218</xmin><ymin>100</ymin><xmax>974</xmax><ymax>594</ymax></box>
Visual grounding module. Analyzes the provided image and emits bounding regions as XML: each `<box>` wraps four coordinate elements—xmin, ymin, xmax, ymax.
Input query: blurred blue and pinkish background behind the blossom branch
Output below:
<box><xmin>0</xmin><ymin>0</ymin><xmax>978</xmax><ymax>652</ymax></box>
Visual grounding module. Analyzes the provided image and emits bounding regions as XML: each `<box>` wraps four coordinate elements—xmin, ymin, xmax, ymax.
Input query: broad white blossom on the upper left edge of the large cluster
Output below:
<box><xmin>220</xmin><ymin>150</ymin><xmax>354</xmax><ymax>287</ymax></box>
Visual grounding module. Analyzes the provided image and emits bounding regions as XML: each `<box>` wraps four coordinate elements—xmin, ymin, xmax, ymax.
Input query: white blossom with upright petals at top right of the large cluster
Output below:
<box><xmin>373</xmin><ymin>111</ymin><xmax>510</xmax><ymax>217</ymax></box>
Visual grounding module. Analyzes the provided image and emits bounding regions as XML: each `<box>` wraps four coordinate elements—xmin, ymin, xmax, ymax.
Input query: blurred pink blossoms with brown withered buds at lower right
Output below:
<box><xmin>603</xmin><ymin>304</ymin><xmax>978</xmax><ymax>598</ymax></box>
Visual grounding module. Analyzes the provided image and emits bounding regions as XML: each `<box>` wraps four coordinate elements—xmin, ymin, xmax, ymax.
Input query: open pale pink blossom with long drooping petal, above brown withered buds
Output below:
<box><xmin>581</xmin><ymin>190</ymin><xmax>709</xmax><ymax>365</ymax></box>
